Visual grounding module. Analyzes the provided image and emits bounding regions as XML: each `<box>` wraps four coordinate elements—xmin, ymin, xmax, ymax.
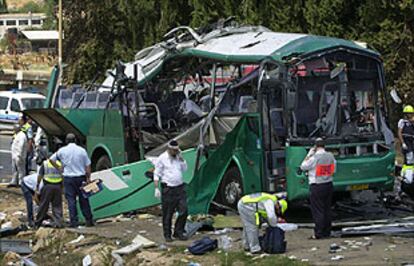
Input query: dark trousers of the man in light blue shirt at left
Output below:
<box><xmin>63</xmin><ymin>176</ymin><xmax>93</xmax><ymax>227</ymax></box>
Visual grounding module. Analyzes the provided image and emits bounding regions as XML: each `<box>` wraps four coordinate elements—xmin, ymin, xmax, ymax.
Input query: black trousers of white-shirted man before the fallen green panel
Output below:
<box><xmin>161</xmin><ymin>184</ymin><xmax>188</xmax><ymax>238</ymax></box>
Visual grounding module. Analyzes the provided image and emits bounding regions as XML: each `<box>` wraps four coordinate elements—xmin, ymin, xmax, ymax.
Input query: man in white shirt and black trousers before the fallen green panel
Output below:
<box><xmin>154</xmin><ymin>140</ymin><xmax>188</xmax><ymax>242</ymax></box>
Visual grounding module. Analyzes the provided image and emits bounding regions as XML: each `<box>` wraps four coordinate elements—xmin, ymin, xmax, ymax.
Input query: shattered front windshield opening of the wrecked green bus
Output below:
<box><xmin>292</xmin><ymin>52</ymin><xmax>379</xmax><ymax>138</ymax></box>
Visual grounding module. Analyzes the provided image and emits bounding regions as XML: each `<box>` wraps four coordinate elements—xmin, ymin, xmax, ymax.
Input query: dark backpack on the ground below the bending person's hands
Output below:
<box><xmin>260</xmin><ymin>226</ymin><xmax>286</xmax><ymax>254</ymax></box>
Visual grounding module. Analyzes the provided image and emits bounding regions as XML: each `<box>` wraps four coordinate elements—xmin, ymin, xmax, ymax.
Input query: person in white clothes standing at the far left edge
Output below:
<box><xmin>9</xmin><ymin>125</ymin><xmax>27</xmax><ymax>186</ymax></box>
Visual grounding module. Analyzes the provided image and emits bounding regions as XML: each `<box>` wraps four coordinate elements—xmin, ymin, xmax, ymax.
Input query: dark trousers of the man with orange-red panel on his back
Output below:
<box><xmin>310</xmin><ymin>182</ymin><xmax>333</xmax><ymax>238</ymax></box>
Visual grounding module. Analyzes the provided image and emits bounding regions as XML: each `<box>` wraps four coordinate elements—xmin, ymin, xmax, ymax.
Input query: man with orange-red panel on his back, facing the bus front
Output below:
<box><xmin>300</xmin><ymin>138</ymin><xmax>336</xmax><ymax>239</ymax></box>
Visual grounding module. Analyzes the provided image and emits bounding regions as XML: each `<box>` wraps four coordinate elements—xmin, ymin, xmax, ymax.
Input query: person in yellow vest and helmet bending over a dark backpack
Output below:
<box><xmin>237</xmin><ymin>192</ymin><xmax>287</xmax><ymax>254</ymax></box>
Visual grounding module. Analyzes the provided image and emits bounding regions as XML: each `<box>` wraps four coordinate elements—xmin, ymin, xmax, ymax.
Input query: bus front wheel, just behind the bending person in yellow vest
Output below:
<box><xmin>218</xmin><ymin>167</ymin><xmax>243</xmax><ymax>209</ymax></box>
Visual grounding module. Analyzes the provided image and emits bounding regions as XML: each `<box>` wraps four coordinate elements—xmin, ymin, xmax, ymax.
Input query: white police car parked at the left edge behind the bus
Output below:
<box><xmin>0</xmin><ymin>90</ymin><xmax>46</xmax><ymax>130</ymax></box>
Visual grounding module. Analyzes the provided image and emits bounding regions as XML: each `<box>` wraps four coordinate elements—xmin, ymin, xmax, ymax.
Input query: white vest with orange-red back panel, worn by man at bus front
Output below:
<box><xmin>315</xmin><ymin>152</ymin><xmax>335</xmax><ymax>184</ymax></box>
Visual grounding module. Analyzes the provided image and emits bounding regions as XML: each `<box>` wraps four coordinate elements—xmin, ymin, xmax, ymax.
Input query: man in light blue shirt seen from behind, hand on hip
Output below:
<box><xmin>49</xmin><ymin>133</ymin><xmax>94</xmax><ymax>227</ymax></box>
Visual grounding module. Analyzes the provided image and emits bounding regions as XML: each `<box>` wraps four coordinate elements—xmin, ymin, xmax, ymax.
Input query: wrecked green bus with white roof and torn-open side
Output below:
<box><xmin>27</xmin><ymin>22</ymin><xmax>395</xmax><ymax>218</ymax></box>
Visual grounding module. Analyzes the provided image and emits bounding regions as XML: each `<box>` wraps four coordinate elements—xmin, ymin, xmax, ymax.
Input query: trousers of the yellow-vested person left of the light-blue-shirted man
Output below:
<box><xmin>35</xmin><ymin>181</ymin><xmax>63</xmax><ymax>227</ymax></box>
